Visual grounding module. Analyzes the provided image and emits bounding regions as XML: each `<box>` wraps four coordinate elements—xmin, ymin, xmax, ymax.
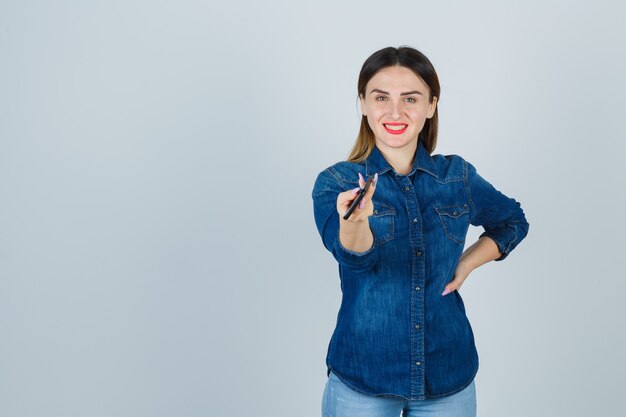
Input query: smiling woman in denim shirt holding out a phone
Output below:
<box><xmin>312</xmin><ymin>47</ymin><xmax>528</xmax><ymax>417</ymax></box>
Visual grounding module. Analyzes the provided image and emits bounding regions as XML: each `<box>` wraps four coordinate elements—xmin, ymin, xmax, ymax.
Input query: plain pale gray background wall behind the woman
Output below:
<box><xmin>0</xmin><ymin>0</ymin><xmax>626</xmax><ymax>417</ymax></box>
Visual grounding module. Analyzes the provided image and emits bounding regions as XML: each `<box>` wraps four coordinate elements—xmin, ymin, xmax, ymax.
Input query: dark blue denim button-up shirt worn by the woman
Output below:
<box><xmin>312</xmin><ymin>142</ymin><xmax>528</xmax><ymax>400</ymax></box>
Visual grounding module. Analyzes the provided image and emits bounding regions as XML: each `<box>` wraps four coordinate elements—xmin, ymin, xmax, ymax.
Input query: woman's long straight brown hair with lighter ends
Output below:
<box><xmin>347</xmin><ymin>46</ymin><xmax>441</xmax><ymax>162</ymax></box>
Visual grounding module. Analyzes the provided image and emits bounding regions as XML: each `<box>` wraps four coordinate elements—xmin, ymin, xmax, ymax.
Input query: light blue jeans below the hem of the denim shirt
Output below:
<box><xmin>322</xmin><ymin>371</ymin><xmax>476</xmax><ymax>417</ymax></box>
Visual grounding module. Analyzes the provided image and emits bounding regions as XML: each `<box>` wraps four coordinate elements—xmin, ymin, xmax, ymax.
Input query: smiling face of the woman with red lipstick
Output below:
<box><xmin>360</xmin><ymin>66</ymin><xmax>437</xmax><ymax>154</ymax></box>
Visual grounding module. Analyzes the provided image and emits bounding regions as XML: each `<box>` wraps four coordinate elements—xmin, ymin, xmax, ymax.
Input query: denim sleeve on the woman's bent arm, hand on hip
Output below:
<box><xmin>465</xmin><ymin>161</ymin><xmax>528</xmax><ymax>261</ymax></box>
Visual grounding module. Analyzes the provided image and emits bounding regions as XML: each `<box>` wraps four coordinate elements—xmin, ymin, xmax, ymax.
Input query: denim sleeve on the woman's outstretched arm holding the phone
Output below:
<box><xmin>312</xmin><ymin>170</ymin><xmax>378</xmax><ymax>272</ymax></box>
